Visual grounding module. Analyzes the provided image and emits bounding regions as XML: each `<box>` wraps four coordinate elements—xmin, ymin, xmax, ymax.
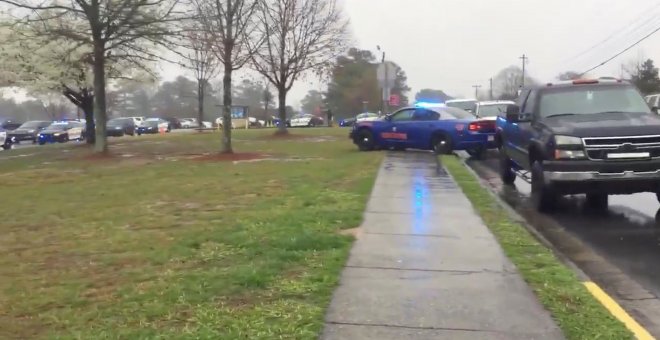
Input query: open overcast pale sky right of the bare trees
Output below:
<box><xmin>159</xmin><ymin>0</ymin><xmax>660</xmax><ymax>104</ymax></box>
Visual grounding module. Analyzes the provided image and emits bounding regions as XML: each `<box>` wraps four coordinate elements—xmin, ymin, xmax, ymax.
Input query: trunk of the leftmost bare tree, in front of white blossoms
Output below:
<box><xmin>93</xmin><ymin>42</ymin><xmax>108</xmax><ymax>153</ymax></box>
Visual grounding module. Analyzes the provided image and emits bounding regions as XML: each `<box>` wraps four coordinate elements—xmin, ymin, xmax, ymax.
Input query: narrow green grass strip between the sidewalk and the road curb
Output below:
<box><xmin>441</xmin><ymin>156</ymin><xmax>634</xmax><ymax>340</ymax></box>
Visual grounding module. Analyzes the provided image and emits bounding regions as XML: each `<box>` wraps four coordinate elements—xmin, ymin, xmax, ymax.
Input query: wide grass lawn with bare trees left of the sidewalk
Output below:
<box><xmin>0</xmin><ymin>128</ymin><xmax>382</xmax><ymax>339</ymax></box>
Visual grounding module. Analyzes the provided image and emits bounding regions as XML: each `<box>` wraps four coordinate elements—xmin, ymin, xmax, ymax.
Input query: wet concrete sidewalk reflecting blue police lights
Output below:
<box><xmin>321</xmin><ymin>152</ymin><xmax>563</xmax><ymax>340</ymax></box>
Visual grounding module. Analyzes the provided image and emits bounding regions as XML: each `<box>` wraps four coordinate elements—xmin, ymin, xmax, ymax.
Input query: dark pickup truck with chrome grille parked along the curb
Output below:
<box><xmin>496</xmin><ymin>78</ymin><xmax>660</xmax><ymax>211</ymax></box>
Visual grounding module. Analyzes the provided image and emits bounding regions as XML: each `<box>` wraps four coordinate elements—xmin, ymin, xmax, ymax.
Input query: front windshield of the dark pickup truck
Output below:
<box><xmin>539</xmin><ymin>85</ymin><xmax>651</xmax><ymax>117</ymax></box>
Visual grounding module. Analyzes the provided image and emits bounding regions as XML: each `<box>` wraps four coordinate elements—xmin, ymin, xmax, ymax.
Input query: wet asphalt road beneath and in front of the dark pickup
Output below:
<box><xmin>468</xmin><ymin>154</ymin><xmax>660</xmax><ymax>337</ymax></box>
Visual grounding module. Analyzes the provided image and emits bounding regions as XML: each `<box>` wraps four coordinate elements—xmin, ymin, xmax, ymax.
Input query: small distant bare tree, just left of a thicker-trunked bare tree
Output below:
<box><xmin>186</xmin><ymin>27</ymin><xmax>220</xmax><ymax>131</ymax></box>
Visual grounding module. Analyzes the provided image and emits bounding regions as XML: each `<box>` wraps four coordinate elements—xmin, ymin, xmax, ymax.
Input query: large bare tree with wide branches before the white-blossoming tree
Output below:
<box><xmin>0</xmin><ymin>0</ymin><xmax>183</xmax><ymax>153</ymax></box>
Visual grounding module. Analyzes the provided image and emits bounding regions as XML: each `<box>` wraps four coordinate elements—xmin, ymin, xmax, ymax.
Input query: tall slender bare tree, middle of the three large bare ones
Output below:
<box><xmin>193</xmin><ymin>0</ymin><xmax>260</xmax><ymax>153</ymax></box>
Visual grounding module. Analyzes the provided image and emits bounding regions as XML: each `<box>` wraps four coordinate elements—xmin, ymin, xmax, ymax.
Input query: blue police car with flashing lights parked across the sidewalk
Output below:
<box><xmin>350</xmin><ymin>103</ymin><xmax>496</xmax><ymax>157</ymax></box>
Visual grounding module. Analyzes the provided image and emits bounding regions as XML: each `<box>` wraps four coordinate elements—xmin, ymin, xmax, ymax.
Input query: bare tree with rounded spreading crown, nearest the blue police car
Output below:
<box><xmin>253</xmin><ymin>0</ymin><xmax>348</xmax><ymax>134</ymax></box>
